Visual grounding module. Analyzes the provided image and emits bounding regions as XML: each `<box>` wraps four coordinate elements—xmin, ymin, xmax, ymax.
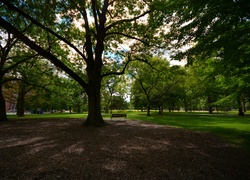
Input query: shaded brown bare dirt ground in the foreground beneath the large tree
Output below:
<box><xmin>0</xmin><ymin>119</ymin><xmax>250</xmax><ymax>180</ymax></box>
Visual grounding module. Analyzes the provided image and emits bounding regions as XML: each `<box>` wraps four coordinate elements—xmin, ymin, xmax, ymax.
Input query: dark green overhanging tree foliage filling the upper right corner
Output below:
<box><xmin>166</xmin><ymin>0</ymin><xmax>250</xmax><ymax>115</ymax></box>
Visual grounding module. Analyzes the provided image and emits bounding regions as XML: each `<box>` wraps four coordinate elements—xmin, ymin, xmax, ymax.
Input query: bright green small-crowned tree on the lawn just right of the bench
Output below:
<box><xmin>129</xmin><ymin>57</ymin><xmax>184</xmax><ymax>116</ymax></box>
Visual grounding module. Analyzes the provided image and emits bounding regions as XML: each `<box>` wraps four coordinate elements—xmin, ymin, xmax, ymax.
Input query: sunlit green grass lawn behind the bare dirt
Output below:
<box><xmin>9</xmin><ymin>111</ymin><xmax>250</xmax><ymax>154</ymax></box>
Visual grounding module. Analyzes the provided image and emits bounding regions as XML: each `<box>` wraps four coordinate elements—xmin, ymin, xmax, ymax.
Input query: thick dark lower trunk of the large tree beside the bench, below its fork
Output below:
<box><xmin>83</xmin><ymin>78</ymin><xmax>105</xmax><ymax>126</ymax></box>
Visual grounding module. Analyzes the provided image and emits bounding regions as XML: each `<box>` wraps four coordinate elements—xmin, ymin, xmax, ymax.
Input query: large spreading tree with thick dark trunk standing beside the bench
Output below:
<box><xmin>0</xmin><ymin>0</ymin><xmax>166</xmax><ymax>126</ymax></box>
